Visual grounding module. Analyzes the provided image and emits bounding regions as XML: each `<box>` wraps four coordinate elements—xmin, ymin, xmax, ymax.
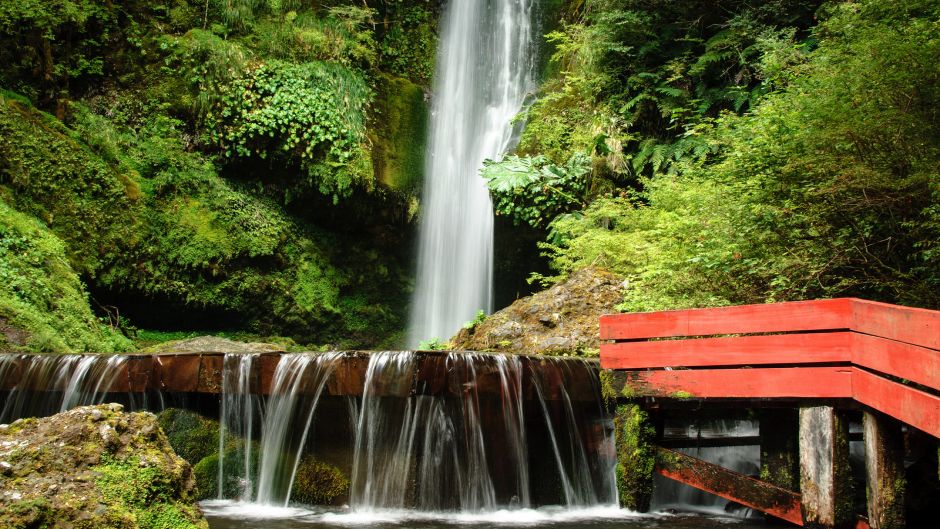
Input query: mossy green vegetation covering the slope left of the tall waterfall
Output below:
<box><xmin>0</xmin><ymin>0</ymin><xmax>438</xmax><ymax>351</ymax></box>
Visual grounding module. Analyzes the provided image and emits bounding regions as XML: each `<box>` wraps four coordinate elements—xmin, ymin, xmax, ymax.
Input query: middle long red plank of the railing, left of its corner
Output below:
<box><xmin>601</xmin><ymin>332</ymin><xmax>853</xmax><ymax>369</ymax></box>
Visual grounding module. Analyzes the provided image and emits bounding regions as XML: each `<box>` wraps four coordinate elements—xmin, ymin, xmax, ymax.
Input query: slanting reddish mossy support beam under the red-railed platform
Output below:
<box><xmin>656</xmin><ymin>448</ymin><xmax>803</xmax><ymax>525</ymax></box>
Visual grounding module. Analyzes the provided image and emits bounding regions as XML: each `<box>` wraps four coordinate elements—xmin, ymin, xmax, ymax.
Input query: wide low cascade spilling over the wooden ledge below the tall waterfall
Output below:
<box><xmin>0</xmin><ymin>352</ymin><xmax>617</xmax><ymax>516</ymax></box>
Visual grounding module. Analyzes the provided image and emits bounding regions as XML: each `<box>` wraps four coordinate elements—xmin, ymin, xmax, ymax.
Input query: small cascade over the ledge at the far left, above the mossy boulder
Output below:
<box><xmin>0</xmin><ymin>354</ymin><xmax>133</xmax><ymax>422</ymax></box>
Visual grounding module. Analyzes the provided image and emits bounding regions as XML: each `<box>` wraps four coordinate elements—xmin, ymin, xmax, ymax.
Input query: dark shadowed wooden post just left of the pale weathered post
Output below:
<box><xmin>759</xmin><ymin>408</ymin><xmax>800</xmax><ymax>490</ymax></box>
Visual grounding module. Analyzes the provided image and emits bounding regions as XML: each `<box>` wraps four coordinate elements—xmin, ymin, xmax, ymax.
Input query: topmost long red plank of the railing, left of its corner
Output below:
<box><xmin>600</xmin><ymin>298</ymin><xmax>854</xmax><ymax>340</ymax></box>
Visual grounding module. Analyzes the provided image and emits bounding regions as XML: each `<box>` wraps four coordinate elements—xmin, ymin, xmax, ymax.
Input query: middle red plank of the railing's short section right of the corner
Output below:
<box><xmin>852</xmin><ymin>333</ymin><xmax>940</xmax><ymax>391</ymax></box>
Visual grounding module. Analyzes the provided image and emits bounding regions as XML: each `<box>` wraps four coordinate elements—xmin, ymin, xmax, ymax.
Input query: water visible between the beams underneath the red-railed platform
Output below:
<box><xmin>652</xmin><ymin>420</ymin><xmax>760</xmax><ymax>516</ymax></box>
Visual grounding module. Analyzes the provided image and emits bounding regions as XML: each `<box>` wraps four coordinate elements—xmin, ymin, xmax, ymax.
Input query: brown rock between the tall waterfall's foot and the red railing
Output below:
<box><xmin>451</xmin><ymin>268</ymin><xmax>623</xmax><ymax>355</ymax></box>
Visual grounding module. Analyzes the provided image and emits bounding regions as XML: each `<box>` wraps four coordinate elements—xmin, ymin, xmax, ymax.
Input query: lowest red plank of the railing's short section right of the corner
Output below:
<box><xmin>852</xmin><ymin>369</ymin><xmax>940</xmax><ymax>437</ymax></box>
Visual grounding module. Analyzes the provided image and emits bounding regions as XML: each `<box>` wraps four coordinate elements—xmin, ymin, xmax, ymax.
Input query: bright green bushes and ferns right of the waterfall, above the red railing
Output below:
<box><xmin>492</xmin><ymin>0</ymin><xmax>940</xmax><ymax>310</ymax></box>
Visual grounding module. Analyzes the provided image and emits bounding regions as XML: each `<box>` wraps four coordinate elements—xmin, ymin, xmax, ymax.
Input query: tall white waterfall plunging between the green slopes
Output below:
<box><xmin>408</xmin><ymin>0</ymin><xmax>536</xmax><ymax>346</ymax></box>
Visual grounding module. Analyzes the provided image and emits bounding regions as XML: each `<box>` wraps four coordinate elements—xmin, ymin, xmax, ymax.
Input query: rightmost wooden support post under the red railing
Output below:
<box><xmin>863</xmin><ymin>412</ymin><xmax>906</xmax><ymax>529</ymax></box>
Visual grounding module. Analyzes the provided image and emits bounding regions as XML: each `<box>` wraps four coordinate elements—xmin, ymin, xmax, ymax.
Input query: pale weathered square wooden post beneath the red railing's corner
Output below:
<box><xmin>800</xmin><ymin>406</ymin><xmax>855</xmax><ymax>529</ymax></box>
